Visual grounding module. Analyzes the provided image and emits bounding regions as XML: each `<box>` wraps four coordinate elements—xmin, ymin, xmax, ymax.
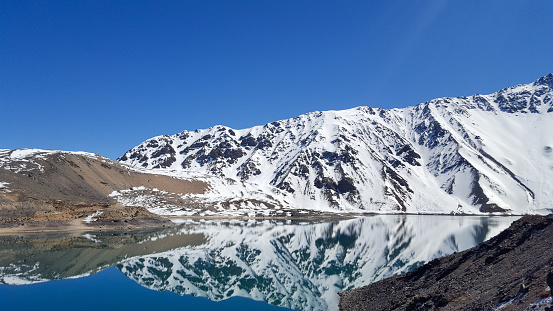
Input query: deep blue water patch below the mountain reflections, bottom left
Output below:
<box><xmin>0</xmin><ymin>267</ymin><xmax>289</xmax><ymax>311</ymax></box>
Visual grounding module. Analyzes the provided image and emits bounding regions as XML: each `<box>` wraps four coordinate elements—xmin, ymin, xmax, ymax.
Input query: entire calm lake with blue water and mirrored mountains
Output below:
<box><xmin>0</xmin><ymin>215</ymin><xmax>519</xmax><ymax>310</ymax></box>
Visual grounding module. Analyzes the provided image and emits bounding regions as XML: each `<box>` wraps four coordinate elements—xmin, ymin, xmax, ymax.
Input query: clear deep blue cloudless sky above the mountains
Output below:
<box><xmin>0</xmin><ymin>0</ymin><xmax>553</xmax><ymax>158</ymax></box>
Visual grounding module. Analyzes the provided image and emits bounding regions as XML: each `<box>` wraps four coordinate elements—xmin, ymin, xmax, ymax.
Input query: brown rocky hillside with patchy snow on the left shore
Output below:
<box><xmin>0</xmin><ymin>149</ymin><xmax>207</xmax><ymax>229</ymax></box>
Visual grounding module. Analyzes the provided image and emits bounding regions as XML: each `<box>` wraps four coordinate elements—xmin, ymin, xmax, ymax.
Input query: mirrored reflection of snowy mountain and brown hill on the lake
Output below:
<box><xmin>0</xmin><ymin>215</ymin><xmax>517</xmax><ymax>310</ymax></box>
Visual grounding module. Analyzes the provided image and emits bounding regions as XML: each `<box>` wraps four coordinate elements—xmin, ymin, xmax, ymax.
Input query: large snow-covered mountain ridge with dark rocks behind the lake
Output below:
<box><xmin>119</xmin><ymin>74</ymin><xmax>553</xmax><ymax>214</ymax></box>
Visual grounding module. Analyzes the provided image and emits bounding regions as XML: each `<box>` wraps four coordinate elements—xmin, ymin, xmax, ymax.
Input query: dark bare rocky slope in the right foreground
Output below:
<box><xmin>340</xmin><ymin>215</ymin><xmax>553</xmax><ymax>310</ymax></box>
